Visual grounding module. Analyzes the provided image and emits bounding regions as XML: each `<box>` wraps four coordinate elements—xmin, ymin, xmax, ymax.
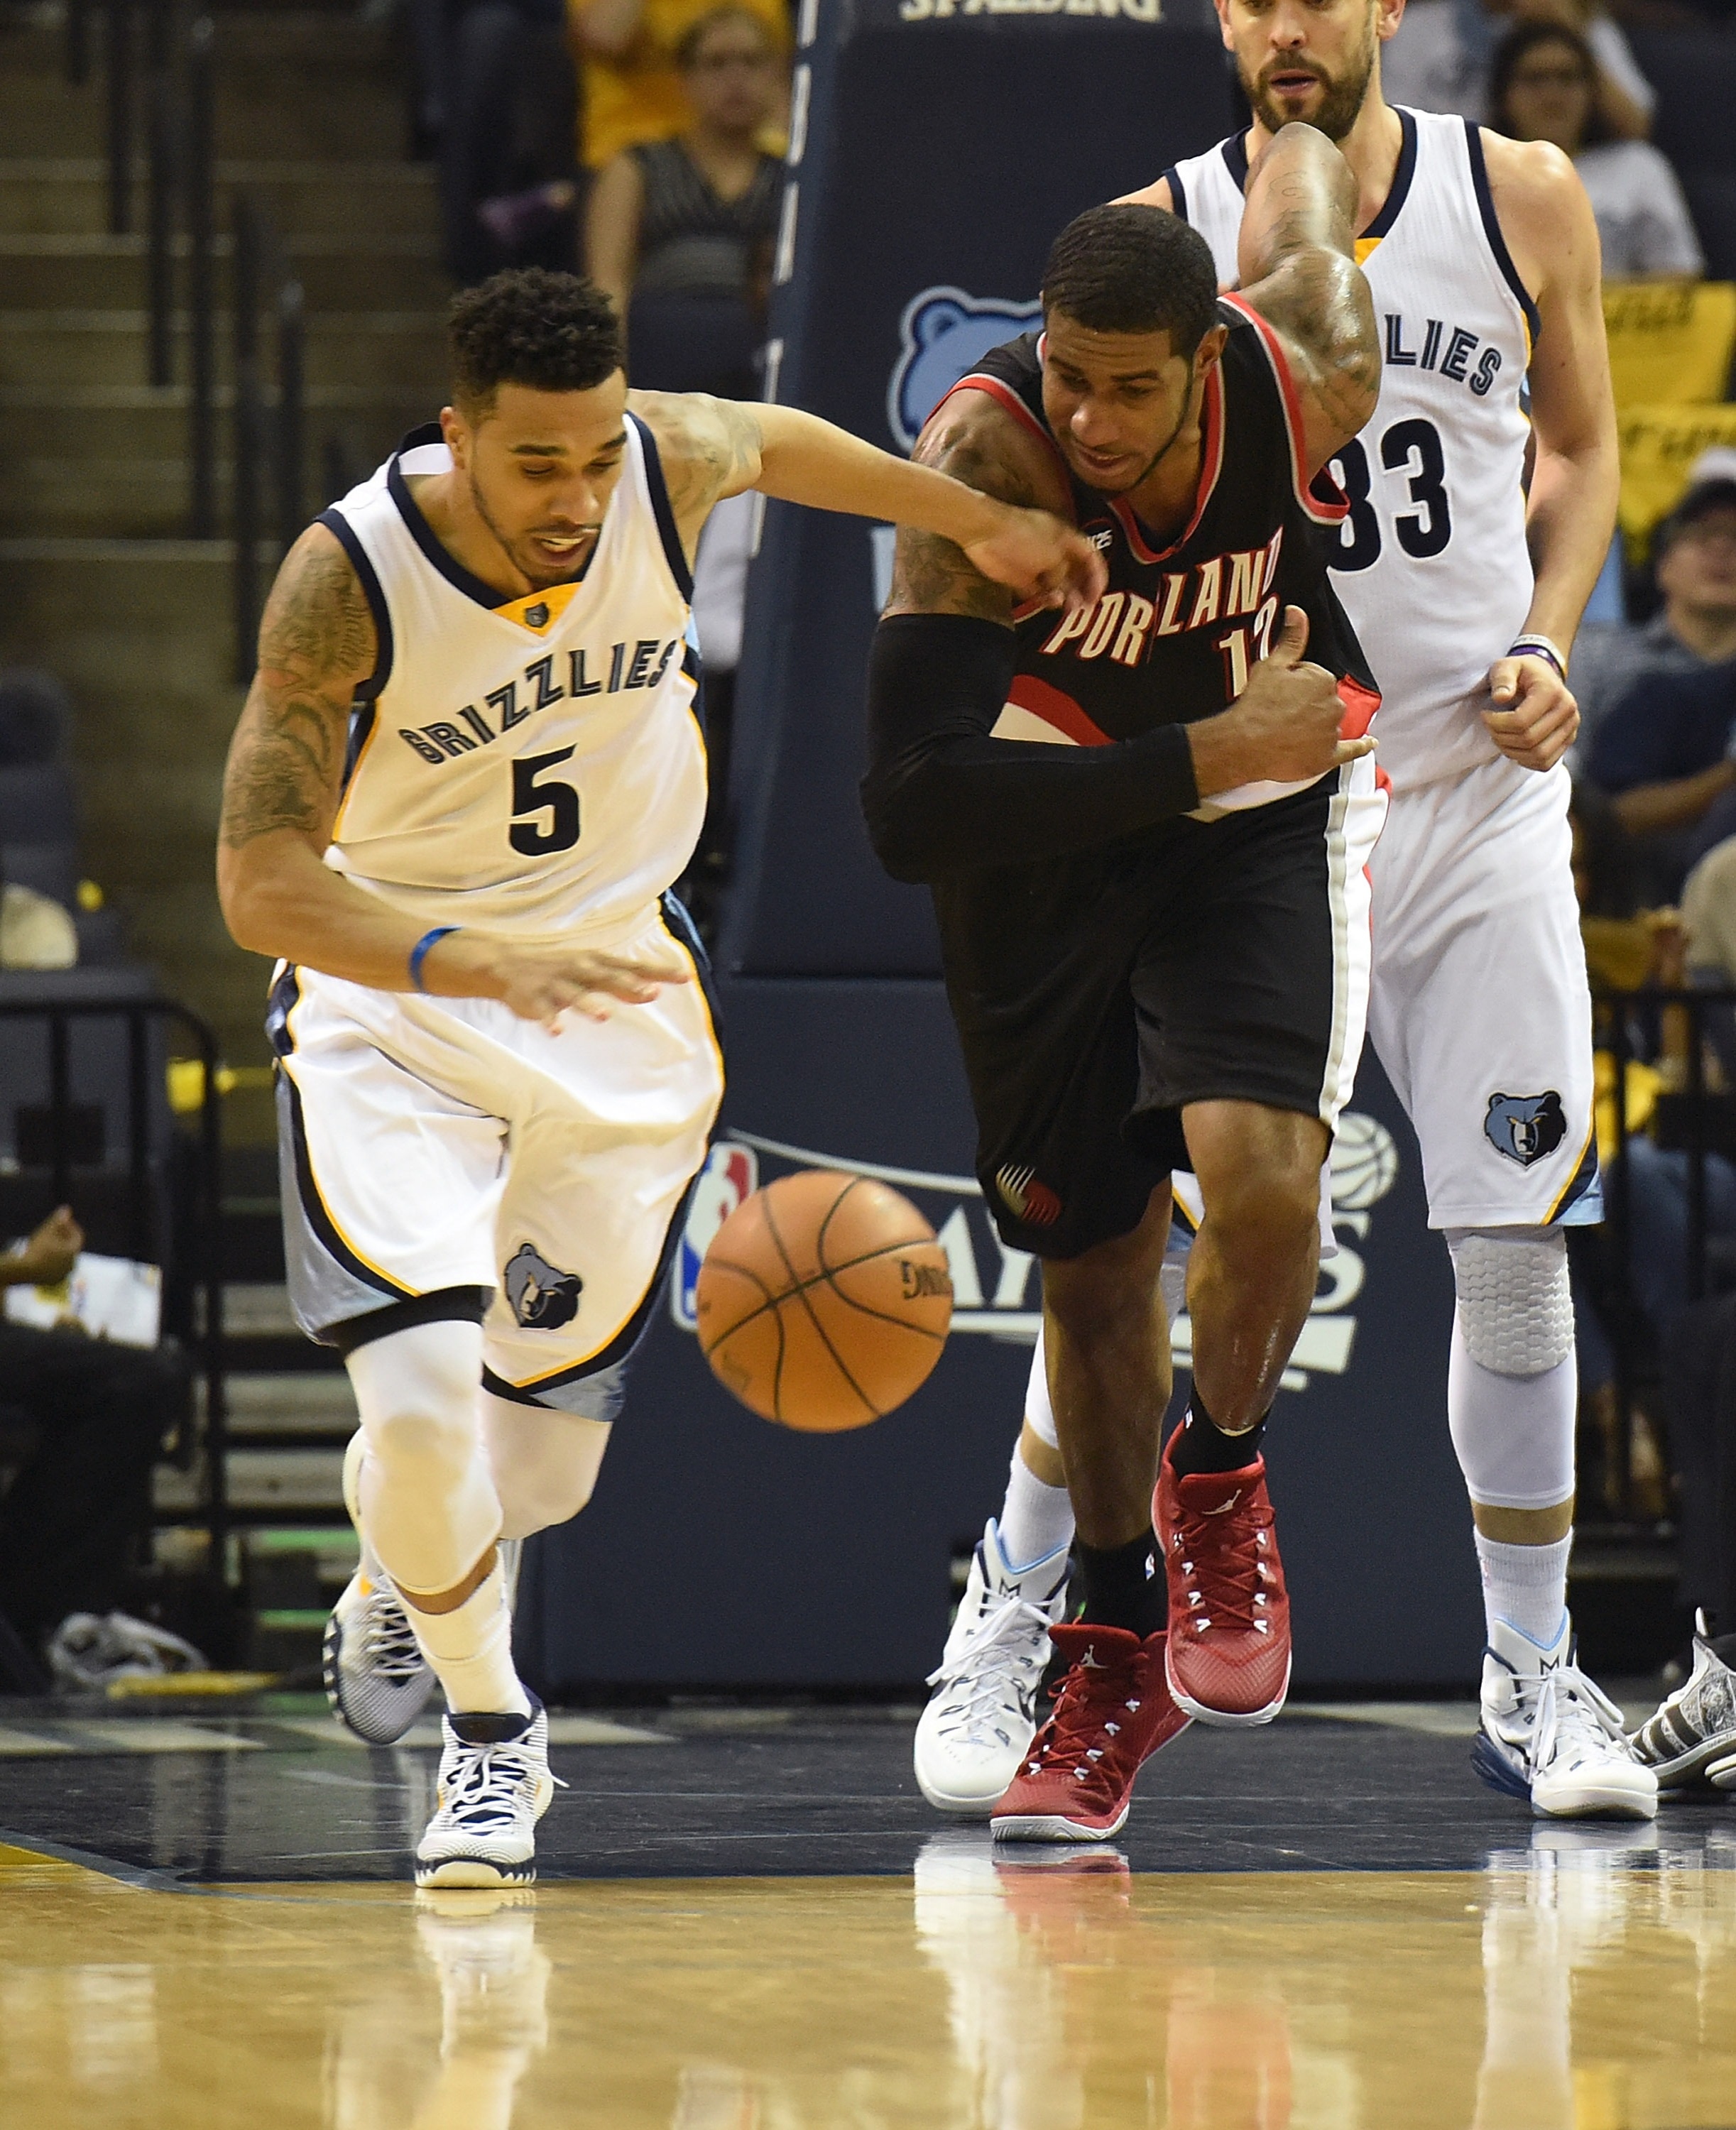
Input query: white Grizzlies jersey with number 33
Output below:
<box><xmin>1165</xmin><ymin>111</ymin><xmax>1538</xmax><ymax>790</ymax></box>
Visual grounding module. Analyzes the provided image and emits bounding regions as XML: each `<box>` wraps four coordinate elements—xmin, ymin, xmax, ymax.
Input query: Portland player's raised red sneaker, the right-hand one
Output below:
<box><xmin>1152</xmin><ymin>1436</ymin><xmax>1291</xmax><ymax>1727</ymax></box>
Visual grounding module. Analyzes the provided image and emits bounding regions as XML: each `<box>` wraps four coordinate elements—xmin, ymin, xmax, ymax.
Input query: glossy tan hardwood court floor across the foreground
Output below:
<box><xmin>0</xmin><ymin>1808</ymin><xmax>1736</xmax><ymax>2130</ymax></box>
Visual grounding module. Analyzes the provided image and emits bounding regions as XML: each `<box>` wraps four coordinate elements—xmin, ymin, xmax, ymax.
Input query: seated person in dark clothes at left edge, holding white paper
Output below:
<box><xmin>0</xmin><ymin>1206</ymin><xmax>187</xmax><ymax>1655</ymax></box>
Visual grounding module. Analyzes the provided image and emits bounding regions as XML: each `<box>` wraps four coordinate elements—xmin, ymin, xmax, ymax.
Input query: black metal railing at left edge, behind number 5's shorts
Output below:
<box><xmin>0</xmin><ymin>999</ymin><xmax>232</xmax><ymax>1583</ymax></box>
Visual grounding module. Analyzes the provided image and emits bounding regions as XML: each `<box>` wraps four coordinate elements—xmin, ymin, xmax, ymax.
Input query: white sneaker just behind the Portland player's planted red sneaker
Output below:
<box><xmin>916</xmin><ymin>1517</ymin><xmax>1067</xmax><ymax>1819</ymax></box>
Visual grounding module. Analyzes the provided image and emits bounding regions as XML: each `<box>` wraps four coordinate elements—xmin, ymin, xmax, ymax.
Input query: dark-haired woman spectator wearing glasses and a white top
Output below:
<box><xmin>1489</xmin><ymin>21</ymin><xmax>1706</xmax><ymax>281</ymax></box>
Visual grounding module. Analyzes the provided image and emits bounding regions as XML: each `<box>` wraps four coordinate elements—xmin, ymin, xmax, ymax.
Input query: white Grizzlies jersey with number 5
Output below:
<box><xmin>322</xmin><ymin>415</ymin><xmax>705</xmax><ymax>944</ymax></box>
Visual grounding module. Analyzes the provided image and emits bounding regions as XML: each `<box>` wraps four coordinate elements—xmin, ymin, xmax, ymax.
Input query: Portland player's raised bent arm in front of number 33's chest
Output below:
<box><xmin>1238</xmin><ymin>124</ymin><xmax>1380</xmax><ymax>477</ymax></box>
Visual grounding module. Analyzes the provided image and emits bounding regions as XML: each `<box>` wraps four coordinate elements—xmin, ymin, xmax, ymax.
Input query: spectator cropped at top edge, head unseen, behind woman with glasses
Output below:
<box><xmin>1380</xmin><ymin>0</ymin><xmax>1657</xmax><ymax>141</ymax></box>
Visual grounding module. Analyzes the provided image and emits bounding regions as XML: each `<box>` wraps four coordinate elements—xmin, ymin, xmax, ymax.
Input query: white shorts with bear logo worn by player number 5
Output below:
<box><xmin>271</xmin><ymin>903</ymin><xmax>722</xmax><ymax>1410</ymax></box>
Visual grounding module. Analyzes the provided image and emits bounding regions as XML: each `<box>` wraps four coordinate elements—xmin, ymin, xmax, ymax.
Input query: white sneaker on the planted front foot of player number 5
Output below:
<box><xmin>415</xmin><ymin>1693</ymin><xmax>556</xmax><ymax>1885</ymax></box>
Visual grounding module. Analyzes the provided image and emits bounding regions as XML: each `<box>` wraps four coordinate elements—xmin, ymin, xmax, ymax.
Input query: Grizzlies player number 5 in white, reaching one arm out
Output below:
<box><xmin>217</xmin><ymin>273</ymin><xmax>1103</xmax><ymax>1885</ymax></box>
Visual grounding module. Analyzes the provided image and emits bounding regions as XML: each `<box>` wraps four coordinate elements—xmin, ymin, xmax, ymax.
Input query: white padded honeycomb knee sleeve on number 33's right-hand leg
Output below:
<box><xmin>1446</xmin><ymin>1227</ymin><xmax>1578</xmax><ymax>1510</ymax></box>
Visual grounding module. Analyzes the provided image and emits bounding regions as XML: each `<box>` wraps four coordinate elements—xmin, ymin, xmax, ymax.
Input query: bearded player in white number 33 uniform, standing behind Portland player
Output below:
<box><xmin>916</xmin><ymin>0</ymin><xmax>1657</xmax><ymax>1817</ymax></box>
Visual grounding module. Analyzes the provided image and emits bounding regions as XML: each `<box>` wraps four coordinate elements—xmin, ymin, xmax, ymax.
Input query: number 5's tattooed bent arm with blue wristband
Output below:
<box><xmin>217</xmin><ymin>524</ymin><xmax>690</xmax><ymax>1022</ymax></box>
